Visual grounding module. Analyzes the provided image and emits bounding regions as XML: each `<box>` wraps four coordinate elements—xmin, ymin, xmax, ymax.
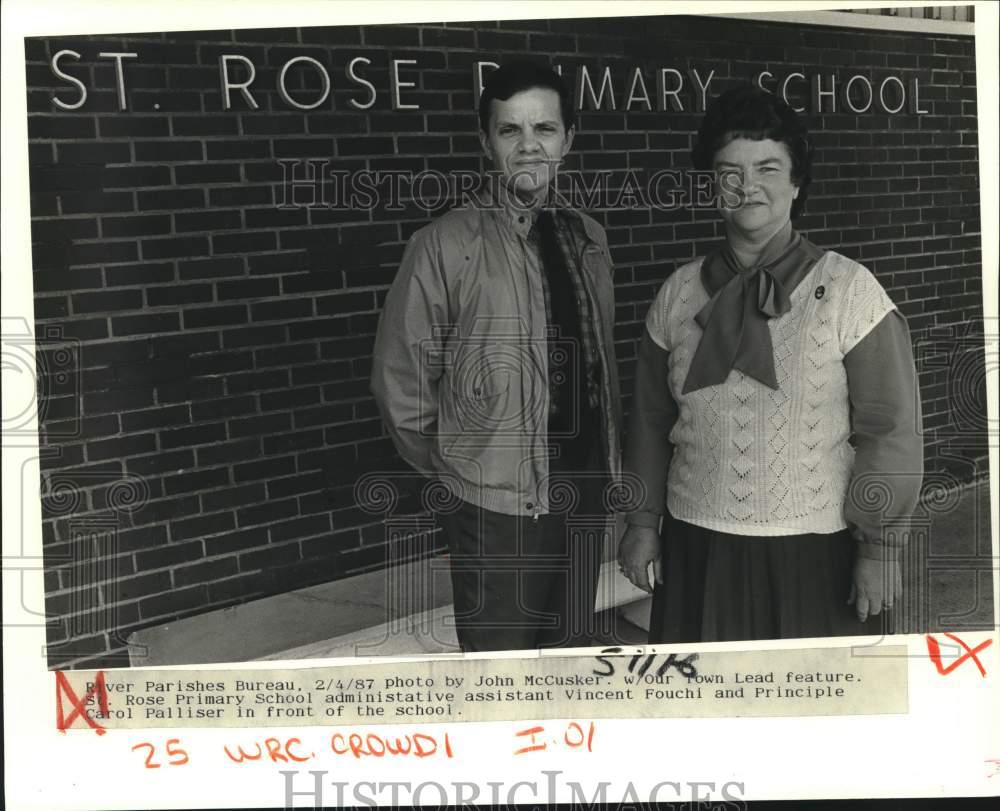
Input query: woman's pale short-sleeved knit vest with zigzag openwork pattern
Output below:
<box><xmin>646</xmin><ymin>252</ymin><xmax>894</xmax><ymax>536</ymax></box>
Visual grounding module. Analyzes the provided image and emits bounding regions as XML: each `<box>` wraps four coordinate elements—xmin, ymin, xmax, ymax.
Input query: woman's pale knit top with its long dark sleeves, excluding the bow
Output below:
<box><xmin>625</xmin><ymin>252</ymin><xmax>923</xmax><ymax>557</ymax></box>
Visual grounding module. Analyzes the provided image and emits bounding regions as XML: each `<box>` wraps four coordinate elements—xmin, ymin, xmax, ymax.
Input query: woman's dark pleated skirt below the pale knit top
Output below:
<box><xmin>649</xmin><ymin>515</ymin><xmax>892</xmax><ymax>644</ymax></box>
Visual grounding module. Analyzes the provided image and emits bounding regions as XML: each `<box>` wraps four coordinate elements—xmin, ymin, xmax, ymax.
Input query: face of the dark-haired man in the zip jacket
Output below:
<box><xmin>479</xmin><ymin>87</ymin><xmax>573</xmax><ymax>202</ymax></box>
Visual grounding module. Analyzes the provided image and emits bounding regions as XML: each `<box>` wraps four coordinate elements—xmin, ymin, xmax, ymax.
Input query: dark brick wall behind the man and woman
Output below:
<box><xmin>26</xmin><ymin>17</ymin><xmax>986</xmax><ymax>667</ymax></box>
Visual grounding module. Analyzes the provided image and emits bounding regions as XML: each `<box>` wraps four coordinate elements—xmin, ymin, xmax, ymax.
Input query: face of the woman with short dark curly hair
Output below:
<box><xmin>713</xmin><ymin>138</ymin><xmax>799</xmax><ymax>238</ymax></box>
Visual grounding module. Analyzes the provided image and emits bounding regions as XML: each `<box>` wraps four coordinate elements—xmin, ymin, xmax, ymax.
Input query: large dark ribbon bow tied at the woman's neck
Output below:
<box><xmin>681</xmin><ymin>235</ymin><xmax>822</xmax><ymax>394</ymax></box>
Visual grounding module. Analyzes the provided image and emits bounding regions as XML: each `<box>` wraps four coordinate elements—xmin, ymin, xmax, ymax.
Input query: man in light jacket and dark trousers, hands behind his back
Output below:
<box><xmin>372</xmin><ymin>62</ymin><xmax>621</xmax><ymax>651</ymax></box>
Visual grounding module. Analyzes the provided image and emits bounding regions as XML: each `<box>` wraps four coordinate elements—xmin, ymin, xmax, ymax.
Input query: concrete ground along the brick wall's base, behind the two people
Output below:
<box><xmin>129</xmin><ymin>482</ymin><xmax>996</xmax><ymax>666</ymax></box>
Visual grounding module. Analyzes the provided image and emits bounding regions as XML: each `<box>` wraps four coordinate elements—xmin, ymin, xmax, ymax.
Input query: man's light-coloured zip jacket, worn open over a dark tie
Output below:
<box><xmin>371</xmin><ymin>197</ymin><xmax>622</xmax><ymax>515</ymax></box>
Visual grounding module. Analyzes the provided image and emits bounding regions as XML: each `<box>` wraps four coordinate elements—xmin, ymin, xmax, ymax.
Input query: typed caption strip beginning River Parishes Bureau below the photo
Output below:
<box><xmin>54</xmin><ymin>646</ymin><xmax>908</xmax><ymax>730</ymax></box>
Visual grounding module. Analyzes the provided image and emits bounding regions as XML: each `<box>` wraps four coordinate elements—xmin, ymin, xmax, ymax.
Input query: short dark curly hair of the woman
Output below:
<box><xmin>691</xmin><ymin>85</ymin><xmax>813</xmax><ymax>219</ymax></box>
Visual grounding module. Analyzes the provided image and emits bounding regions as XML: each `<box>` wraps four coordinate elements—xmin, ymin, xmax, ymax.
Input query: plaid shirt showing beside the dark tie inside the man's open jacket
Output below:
<box><xmin>528</xmin><ymin>204</ymin><xmax>601</xmax><ymax>416</ymax></box>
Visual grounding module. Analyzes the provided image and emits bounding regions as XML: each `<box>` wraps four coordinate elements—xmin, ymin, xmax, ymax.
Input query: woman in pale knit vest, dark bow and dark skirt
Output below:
<box><xmin>619</xmin><ymin>86</ymin><xmax>923</xmax><ymax>643</ymax></box>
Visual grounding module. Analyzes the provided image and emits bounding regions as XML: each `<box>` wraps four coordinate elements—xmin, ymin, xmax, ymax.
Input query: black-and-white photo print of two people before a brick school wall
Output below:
<box><xmin>3</xmin><ymin>3</ymin><xmax>1000</xmax><ymax>804</ymax></box>
